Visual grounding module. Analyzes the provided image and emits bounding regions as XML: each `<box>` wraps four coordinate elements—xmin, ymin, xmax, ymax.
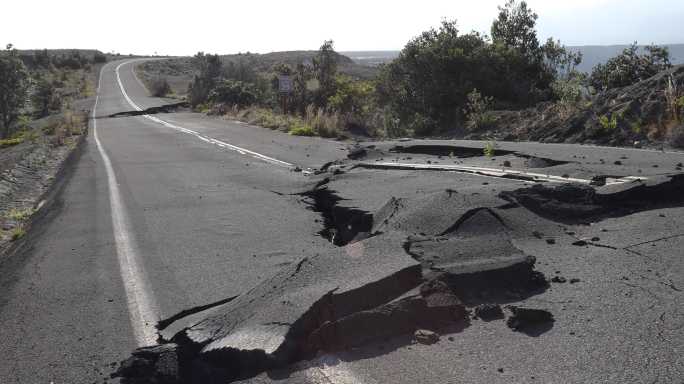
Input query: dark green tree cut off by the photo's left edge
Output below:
<box><xmin>0</xmin><ymin>44</ymin><xmax>29</xmax><ymax>137</ymax></box>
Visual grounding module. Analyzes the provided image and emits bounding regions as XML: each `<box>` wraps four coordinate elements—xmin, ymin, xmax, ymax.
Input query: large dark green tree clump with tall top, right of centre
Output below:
<box><xmin>378</xmin><ymin>0</ymin><xmax>581</xmax><ymax>136</ymax></box>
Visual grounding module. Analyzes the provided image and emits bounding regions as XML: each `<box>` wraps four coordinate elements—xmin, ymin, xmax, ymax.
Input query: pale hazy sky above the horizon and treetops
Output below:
<box><xmin>5</xmin><ymin>0</ymin><xmax>684</xmax><ymax>55</ymax></box>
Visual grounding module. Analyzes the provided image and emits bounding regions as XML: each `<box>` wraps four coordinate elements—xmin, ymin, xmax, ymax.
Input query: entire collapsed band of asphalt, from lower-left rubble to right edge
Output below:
<box><xmin>117</xmin><ymin>158</ymin><xmax>684</xmax><ymax>384</ymax></box>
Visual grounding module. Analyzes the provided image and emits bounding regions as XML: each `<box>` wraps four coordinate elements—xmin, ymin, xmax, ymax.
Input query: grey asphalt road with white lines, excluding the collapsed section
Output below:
<box><xmin>0</xmin><ymin>58</ymin><xmax>684</xmax><ymax>383</ymax></box>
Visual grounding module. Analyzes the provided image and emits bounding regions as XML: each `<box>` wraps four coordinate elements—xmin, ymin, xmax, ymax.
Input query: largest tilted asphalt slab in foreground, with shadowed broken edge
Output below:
<box><xmin>115</xmin><ymin>234</ymin><xmax>430</xmax><ymax>382</ymax></box>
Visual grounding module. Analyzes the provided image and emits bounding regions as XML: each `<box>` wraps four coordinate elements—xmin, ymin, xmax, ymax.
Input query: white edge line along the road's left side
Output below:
<box><xmin>92</xmin><ymin>63</ymin><xmax>158</xmax><ymax>347</ymax></box>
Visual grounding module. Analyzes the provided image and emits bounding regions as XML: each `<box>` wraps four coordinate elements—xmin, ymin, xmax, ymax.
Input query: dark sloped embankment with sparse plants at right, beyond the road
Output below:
<box><xmin>467</xmin><ymin>66</ymin><xmax>684</xmax><ymax>146</ymax></box>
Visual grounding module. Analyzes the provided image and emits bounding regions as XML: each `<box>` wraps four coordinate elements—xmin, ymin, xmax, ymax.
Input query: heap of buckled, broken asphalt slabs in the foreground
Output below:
<box><xmin>113</xmin><ymin>178</ymin><xmax>546</xmax><ymax>383</ymax></box>
